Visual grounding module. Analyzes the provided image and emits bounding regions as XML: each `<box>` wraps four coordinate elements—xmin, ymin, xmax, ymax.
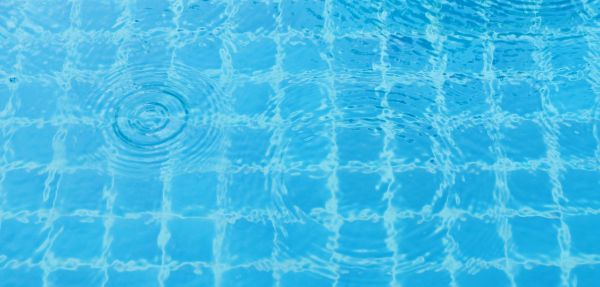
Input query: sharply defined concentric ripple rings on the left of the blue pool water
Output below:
<box><xmin>90</xmin><ymin>64</ymin><xmax>221</xmax><ymax>173</ymax></box>
